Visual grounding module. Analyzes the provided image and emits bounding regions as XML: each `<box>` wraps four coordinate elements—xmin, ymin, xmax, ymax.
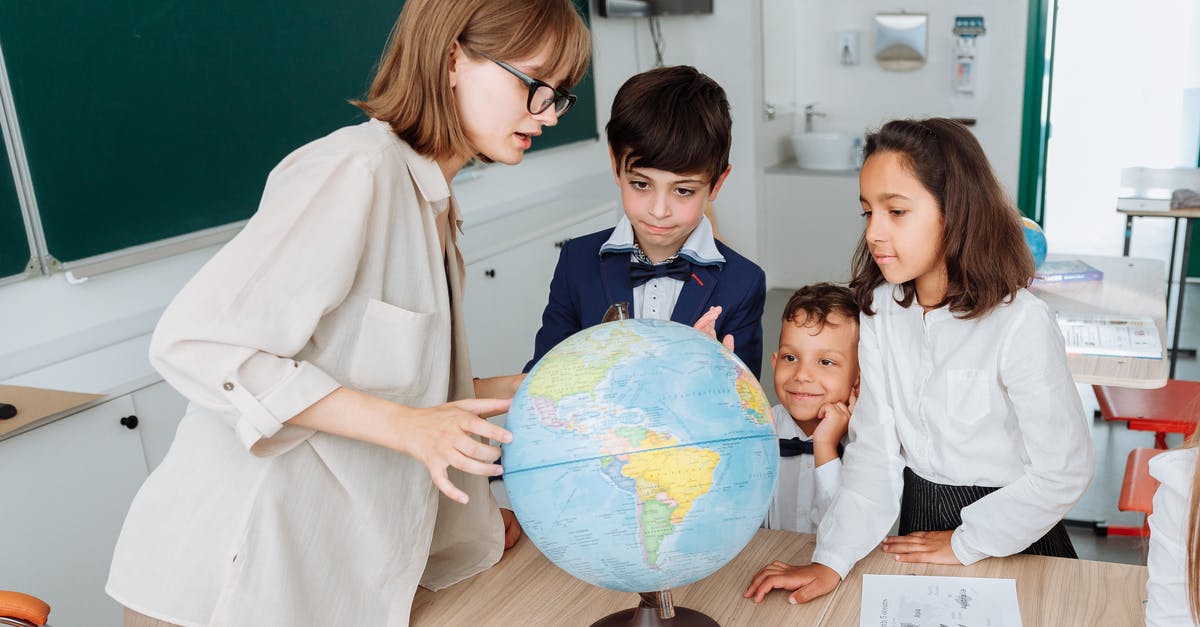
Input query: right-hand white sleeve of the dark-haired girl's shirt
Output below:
<box><xmin>950</xmin><ymin>306</ymin><xmax>1093</xmax><ymax>565</ymax></box>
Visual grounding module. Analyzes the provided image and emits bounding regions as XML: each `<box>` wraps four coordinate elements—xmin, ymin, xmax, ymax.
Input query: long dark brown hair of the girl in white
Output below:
<box><xmin>850</xmin><ymin>118</ymin><xmax>1033</xmax><ymax>320</ymax></box>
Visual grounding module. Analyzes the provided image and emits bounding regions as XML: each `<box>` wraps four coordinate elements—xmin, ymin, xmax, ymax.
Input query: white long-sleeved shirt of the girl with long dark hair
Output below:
<box><xmin>812</xmin><ymin>283</ymin><xmax>1092</xmax><ymax>577</ymax></box>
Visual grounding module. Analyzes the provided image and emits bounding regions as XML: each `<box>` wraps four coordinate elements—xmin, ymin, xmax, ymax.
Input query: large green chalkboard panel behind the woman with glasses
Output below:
<box><xmin>0</xmin><ymin>0</ymin><xmax>596</xmax><ymax>263</ymax></box>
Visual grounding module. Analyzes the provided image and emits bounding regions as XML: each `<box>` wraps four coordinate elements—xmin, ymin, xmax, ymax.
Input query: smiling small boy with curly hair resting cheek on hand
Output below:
<box><xmin>766</xmin><ymin>283</ymin><xmax>858</xmax><ymax>533</ymax></box>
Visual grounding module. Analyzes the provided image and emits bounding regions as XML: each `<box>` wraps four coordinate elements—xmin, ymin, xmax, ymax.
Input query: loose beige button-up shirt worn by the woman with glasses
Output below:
<box><xmin>106</xmin><ymin>120</ymin><xmax>503</xmax><ymax>626</ymax></box>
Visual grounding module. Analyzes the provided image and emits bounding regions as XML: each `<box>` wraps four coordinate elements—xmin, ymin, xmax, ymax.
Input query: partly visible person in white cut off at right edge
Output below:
<box><xmin>1146</xmin><ymin>431</ymin><xmax>1200</xmax><ymax>627</ymax></box>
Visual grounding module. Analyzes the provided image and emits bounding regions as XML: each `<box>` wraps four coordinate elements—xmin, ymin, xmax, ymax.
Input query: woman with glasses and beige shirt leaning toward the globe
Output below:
<box><xmin>106</xmin><ymin>0</ymin><xmax>590</xmax><ymax>626</ymax></box>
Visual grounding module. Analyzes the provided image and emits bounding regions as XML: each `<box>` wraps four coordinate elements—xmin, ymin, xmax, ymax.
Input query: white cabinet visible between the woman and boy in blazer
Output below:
<box><xmin>463</xmin><ymin>199</ymin><xmax>619</xmax><ymax>377</ymax></box>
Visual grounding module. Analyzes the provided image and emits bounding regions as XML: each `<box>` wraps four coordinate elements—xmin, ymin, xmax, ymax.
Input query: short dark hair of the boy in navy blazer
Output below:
<box><xmin>605</xmin><ymin>65</ymin><xmax>733</xmax><ymax>185</ymax></box>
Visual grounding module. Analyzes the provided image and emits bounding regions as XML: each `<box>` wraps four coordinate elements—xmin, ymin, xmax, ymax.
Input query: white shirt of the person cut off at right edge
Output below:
<box><xmin>1146</xmin><ymin>448</ymin><xmax>1200</xmax><ymax>627</ymax></box>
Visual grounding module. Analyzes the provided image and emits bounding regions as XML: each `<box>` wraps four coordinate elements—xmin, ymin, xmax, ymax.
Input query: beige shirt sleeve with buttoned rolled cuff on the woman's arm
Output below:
<box><xmin>150</xmin><ymin>149</ymin><xmax>374</xmax><ymax>455</ymax></box>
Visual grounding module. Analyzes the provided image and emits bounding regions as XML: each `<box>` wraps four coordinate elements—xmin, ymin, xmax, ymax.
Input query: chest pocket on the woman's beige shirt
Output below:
<box><xmin>349</xmin><ymin>299</ymin><xmax>437</xmax><ymax>396</ymax></box>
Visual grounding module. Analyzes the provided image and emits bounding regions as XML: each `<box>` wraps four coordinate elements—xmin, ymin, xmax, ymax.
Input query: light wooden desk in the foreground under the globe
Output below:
<box><xmin>412</xmin><ymin>530</ymin><xmax>1146</xmax><ymax>627</ymax></box>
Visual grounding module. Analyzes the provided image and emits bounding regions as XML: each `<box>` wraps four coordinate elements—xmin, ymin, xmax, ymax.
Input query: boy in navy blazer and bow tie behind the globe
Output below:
<box><xmin>524</xmin><ymin>66</ymin><xmax>767</xmax><ymax>377</ymax></box>
